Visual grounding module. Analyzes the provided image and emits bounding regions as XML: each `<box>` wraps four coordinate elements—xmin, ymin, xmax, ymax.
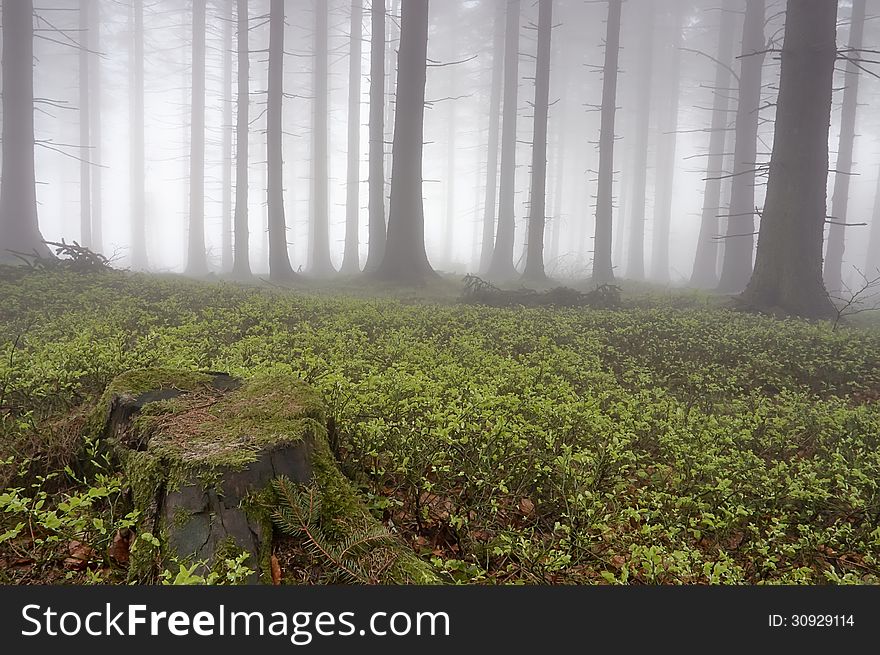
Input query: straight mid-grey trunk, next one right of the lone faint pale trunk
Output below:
<box><xmin>186</xmin><ymin>0</ymin><xmax>208</xmax><ymax>275</ymax></box>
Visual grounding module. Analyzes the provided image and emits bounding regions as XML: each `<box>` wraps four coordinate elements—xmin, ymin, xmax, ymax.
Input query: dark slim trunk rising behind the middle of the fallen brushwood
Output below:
<box><xmin>523</xmin><ymin>0</ymin><xmax>553</xmax><ymax>282</ymax></box>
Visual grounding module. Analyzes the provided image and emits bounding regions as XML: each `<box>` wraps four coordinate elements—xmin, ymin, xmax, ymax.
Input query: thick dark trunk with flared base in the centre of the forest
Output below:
<box><xmin>376</xmin><ymin>0</ymin><xmax>434</xmax><ymax>283</ymax></box>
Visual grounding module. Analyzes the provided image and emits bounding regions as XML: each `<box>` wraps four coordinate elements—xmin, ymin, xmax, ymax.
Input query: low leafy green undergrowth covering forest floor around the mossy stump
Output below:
<box><xmin>0</xmin><ymin>269</ymin><xmax>880</xmax><ymax>584</ymax></box>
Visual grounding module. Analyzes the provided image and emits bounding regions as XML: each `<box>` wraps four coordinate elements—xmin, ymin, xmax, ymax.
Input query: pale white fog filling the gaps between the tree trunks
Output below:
<box><xmin>4</xmin><ymin>0</ymin><xmax>880</xmax><ymax>284</ymax></box>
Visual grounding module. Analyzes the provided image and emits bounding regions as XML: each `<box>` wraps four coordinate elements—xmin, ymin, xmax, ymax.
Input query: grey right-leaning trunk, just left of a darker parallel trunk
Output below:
<box><xmin>691</xmin><ymin>0</ymin><xmax>736</xmax><ymax>289</ymax></box>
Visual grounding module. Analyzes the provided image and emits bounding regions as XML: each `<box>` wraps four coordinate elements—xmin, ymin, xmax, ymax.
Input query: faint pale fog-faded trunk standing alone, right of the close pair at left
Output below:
<box><xmin>129</xmin><ymin>0</ymin><xmax>147</xmax><ymax>270</ymax></box>
